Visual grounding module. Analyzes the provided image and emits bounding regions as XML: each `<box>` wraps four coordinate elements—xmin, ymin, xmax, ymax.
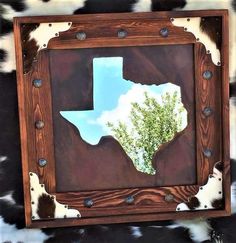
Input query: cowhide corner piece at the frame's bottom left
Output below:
<box><xmin>29</xmin><ymin>172</ymin><xmax>81</xmax><ymax>220</ymax></box>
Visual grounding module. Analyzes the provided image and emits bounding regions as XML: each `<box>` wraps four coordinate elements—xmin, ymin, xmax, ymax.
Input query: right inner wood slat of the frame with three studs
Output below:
<box><xmin>195</xmin><ymin>43</ymin><xmax>222</xmax><ymax>185</ymax></box>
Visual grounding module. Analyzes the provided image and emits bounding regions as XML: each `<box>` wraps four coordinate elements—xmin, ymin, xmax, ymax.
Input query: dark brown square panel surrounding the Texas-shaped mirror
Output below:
<box><xmin>50</xmin><ymin>45</ymin><xmax>196</xmax><ymax>192</ymax></box>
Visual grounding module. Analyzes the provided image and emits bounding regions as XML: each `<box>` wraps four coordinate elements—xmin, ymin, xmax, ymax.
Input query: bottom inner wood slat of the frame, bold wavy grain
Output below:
<box><xmin>56</xmin><ymin>186</ymin><xmax>199</xmax><ymax>217</ymax></box>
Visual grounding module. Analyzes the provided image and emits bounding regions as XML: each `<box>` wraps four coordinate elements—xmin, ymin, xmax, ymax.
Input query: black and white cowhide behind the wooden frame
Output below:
<box><xmin>0</xmin><ymin>0</ymin><xmax>236</xmax><ymax>243</ymax></box>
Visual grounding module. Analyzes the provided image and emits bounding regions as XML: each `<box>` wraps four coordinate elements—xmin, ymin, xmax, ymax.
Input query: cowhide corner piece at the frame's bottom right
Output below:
<box><xmin>176</xmin><ymin>162</ymin><xmax>223</xmax><ymax>211</ymax></box>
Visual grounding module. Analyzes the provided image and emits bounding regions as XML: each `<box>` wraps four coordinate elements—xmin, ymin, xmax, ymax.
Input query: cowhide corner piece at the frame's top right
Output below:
<box><xmin>171</xmin><ymin>17</ymin><xmax>221</xmax><ymax>66</ymax></box>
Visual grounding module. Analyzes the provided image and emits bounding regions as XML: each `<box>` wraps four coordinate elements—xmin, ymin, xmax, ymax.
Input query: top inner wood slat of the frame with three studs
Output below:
<box><xmin>48</xmin><ymin>20</ymin><xmax>195</xmax><ymax>49</ymax></box>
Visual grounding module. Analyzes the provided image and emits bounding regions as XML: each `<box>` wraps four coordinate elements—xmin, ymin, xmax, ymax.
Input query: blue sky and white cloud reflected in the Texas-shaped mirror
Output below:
<box><xmin>60</xmin><ymin>57</ymin><xmax>186</xmax><ymax>145</ymax></box>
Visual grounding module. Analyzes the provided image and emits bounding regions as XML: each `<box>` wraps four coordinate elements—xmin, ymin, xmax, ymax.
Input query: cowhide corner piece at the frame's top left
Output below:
<box><xmin>21</xmin><ymin>22</ymin><xmax>72</xmax><ymax>74</ymax></box>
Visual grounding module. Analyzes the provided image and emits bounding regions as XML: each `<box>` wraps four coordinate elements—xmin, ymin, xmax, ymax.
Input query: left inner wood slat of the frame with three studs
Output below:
<box><xmin>19</xmin><ymin>51</ymin><xmax>55</xmax><ymax>192</ymax></box>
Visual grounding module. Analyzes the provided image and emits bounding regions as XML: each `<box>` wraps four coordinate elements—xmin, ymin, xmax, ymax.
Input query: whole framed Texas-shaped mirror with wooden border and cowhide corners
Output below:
<box><xmin>15</xmin><ymin>11</ymin><xmax>229</xmax><ymax>227</ymax></box>
